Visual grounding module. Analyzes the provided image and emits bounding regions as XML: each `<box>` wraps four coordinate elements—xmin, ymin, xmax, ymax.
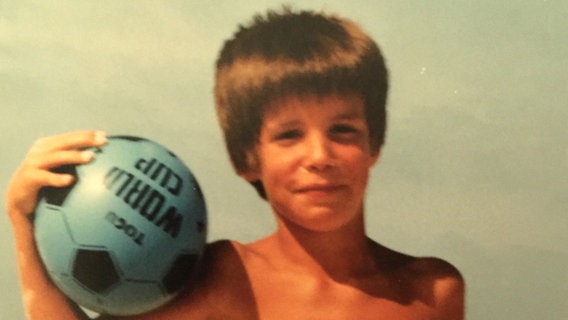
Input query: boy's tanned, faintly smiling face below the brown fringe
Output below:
<box><xmin>244</xmin><ymin>94</ymin><xmax>378</xmax><ymax>231</ymax></box>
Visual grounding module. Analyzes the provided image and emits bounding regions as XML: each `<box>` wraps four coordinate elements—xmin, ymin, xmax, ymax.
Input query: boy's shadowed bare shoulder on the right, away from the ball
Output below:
<box><xmin>368</xmin><ymin>244</ymin><xmax>465</xmax><ymax>319</ymax></box>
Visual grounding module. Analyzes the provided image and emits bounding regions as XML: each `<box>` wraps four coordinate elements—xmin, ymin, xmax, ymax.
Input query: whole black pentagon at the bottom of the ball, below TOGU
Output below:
<box><xmin>73</xmin><ymin>249</ymin><xmax>120</xmax><ymax>294</ymax></box>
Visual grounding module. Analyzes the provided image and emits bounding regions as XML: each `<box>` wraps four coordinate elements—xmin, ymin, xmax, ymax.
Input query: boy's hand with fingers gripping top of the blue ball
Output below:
<box><xmin>6</xmin><ymin>131</ymin><xmax>106</xmax><ymax>218</ymax></box>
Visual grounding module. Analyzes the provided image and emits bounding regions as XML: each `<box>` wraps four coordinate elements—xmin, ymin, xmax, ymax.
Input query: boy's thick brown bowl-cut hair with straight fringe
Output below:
<box><xmin>215</xmin><ymin>8</ymin><xmax>388</xmax><ymax>195</ymax></box>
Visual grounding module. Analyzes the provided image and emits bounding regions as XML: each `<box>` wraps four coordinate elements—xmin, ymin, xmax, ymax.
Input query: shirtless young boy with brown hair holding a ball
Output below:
<box><xmin>7</xmin><ymin>10</ymin><xmax>464</xmax><ymax>320</ymax></box>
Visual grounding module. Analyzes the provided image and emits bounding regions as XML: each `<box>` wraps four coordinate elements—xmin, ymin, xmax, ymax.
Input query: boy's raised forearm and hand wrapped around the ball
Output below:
<box><xmin>6</xmin><ymin>131</ymin><xmax>105</xmax><ymax>320</ymax></box>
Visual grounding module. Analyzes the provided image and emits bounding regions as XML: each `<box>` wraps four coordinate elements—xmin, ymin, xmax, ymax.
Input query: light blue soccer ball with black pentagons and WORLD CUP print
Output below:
<box><xmin>34</xmin><ymin>136</ymin><xmax>207</xmax><ymax>315</ymax></box>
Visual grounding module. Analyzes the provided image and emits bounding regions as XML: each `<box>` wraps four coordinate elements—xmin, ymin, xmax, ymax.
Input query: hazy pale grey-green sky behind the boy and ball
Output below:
<box><xmin>0</xmin><ymin>0</ymin><xmax>568</xmax><ymax>320</ymax></box>
